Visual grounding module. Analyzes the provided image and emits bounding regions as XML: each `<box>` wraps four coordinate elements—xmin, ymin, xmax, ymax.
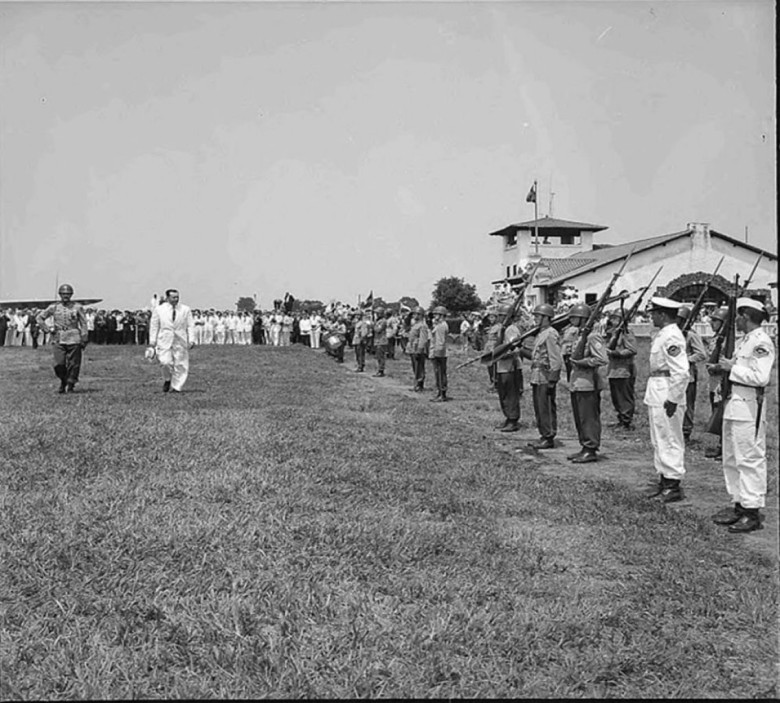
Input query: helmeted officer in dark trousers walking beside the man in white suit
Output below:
<box><xmin>36</xmin><ymin>283</ymin><xmax>89</xmax><ymax>393</ymax></box>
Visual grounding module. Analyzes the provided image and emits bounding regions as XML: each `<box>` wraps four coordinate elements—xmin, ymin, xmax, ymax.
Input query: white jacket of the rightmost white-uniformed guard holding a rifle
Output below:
<box><xmin>723</xmin><ymin>327</ymin><xmax>775</xmax><ymax>421</ymax></box>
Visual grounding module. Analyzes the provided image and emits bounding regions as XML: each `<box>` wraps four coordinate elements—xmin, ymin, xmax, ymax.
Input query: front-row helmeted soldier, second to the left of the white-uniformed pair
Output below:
<box><xmin>523</xmin><ymin>303</ymin><xmax>563</xmax><ymax>449</ymax></box>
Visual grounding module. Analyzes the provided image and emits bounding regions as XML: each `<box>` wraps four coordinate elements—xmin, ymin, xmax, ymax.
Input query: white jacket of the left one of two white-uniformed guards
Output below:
<box><xmin>645</xmin><ymin>323</ymin><xmax>690</xmax><ymax>408</ymax></box>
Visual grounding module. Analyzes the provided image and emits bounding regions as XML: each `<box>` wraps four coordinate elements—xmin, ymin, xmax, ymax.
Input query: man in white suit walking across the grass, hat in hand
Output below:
<box><xmin>149</xmin><ymin>288</ymin><xmax>195</xmax><ymax>393</ymax></box>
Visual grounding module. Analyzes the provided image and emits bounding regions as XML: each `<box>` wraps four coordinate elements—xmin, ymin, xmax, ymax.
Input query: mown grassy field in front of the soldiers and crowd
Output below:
<box><xmin>0</xmin><ymin>345</ymin><xmax>779</xmax><ymax>699</ymax></box>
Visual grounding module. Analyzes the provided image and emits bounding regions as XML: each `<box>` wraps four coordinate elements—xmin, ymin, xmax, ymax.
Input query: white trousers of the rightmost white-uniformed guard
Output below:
<box><xmin>723</xmin><ymin>416</ymin><xmax>766</xmax><ymax>508</ymax></box>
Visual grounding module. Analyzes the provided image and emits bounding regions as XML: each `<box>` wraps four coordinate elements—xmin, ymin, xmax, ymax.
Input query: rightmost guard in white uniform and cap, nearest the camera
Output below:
<box><xmin>707</xmin><ymin>298</ymin><xmax>775</xmax><ymax>533</ymax></box>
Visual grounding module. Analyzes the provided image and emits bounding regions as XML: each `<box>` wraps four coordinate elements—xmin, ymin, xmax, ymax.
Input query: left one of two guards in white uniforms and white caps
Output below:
<box><xmin>645</xmin><ymin>297</ymin><xmax>689</xmax><ymax>503</ymax></box>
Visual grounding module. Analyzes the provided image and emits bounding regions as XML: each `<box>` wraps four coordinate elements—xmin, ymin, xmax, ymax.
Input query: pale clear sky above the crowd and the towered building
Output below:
<box><xmin>0</xmin><ymin>0</ymin><xmax>777</xmax><ymax>308</ymax></box>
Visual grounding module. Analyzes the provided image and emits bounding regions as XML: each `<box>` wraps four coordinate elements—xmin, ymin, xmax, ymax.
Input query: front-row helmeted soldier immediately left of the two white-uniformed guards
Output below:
<box><xmin>566</xmin><ymin>303</ymin><xmax>607</xmax><ymax>464</ymax></box>
